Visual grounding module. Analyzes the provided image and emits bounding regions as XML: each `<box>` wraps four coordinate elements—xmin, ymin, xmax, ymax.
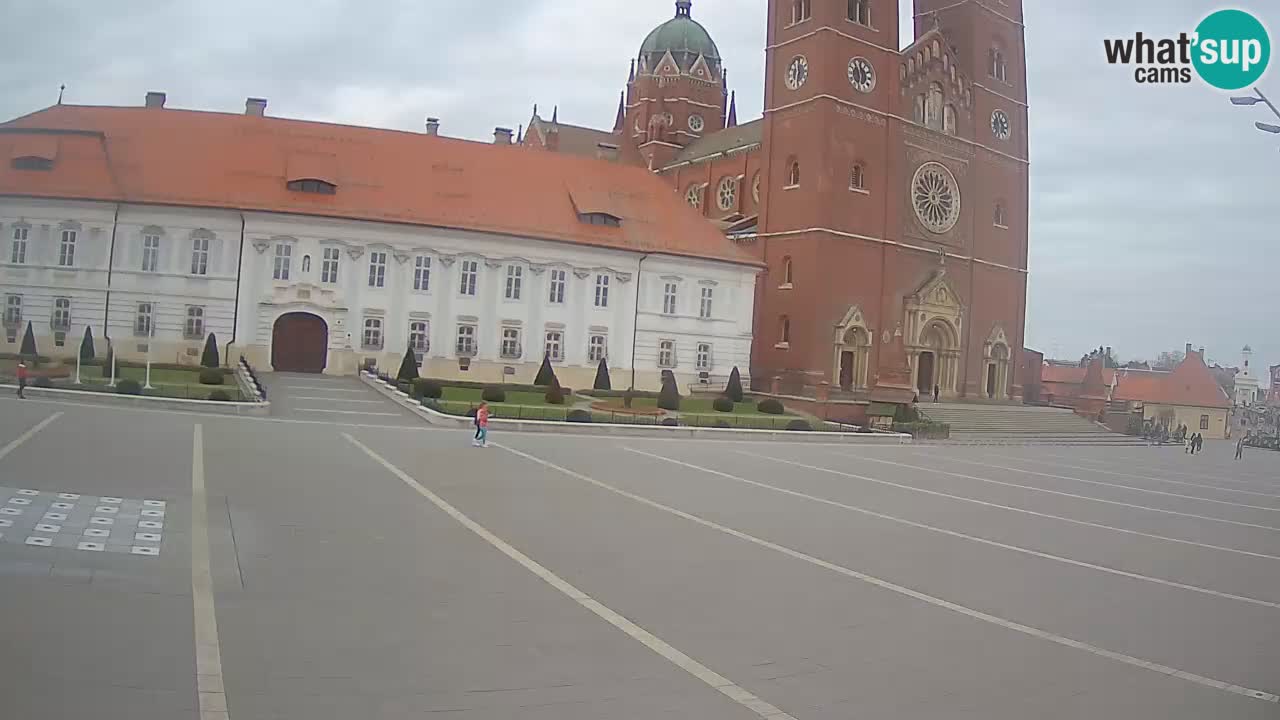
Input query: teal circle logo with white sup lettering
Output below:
<box><xmin>1192</xmin><ymin>10</ymin><xmax>1271</xmax><ymax>90</ymax></box>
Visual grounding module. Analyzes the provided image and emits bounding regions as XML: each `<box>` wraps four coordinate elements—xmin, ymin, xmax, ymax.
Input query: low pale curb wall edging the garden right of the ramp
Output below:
<box><xmin>360</xmin><ymin>373</ymin><xmax>913</xmax><ymax>445</ymax></box>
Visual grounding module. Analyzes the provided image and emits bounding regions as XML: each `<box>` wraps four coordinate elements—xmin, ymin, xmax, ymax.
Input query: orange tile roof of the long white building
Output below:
<box><xmin>0</xmin><ymin>105</ymin><xmax>759</xmax><ymax>265</ymax></box>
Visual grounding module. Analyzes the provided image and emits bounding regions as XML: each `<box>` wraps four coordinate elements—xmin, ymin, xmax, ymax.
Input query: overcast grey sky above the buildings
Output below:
<box><xmin>0</xmin><ymin>0</ymin><xmax>1280</xmax><ymax>379</ymax></box>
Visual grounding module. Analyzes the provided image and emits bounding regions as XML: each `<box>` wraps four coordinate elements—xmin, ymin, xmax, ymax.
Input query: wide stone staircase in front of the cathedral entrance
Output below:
<box><xmin>919</xmin><ymin>402</ymin><xmax>1143</xmax><ymax>445</ymax></box>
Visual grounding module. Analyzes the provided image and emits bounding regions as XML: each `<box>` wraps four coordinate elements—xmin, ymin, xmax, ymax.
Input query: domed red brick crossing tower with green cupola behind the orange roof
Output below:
<box><xmin>620</xmin><ymin>0</ymin><xmax>727</xmax><ymax>168</ymax></box>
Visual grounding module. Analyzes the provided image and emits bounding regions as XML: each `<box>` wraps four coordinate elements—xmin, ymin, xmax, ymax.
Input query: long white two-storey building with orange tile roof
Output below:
<box><xmin>0</xmin><ymin>94</ymin><xmax>758</xmax><ymax>388</ymax></box>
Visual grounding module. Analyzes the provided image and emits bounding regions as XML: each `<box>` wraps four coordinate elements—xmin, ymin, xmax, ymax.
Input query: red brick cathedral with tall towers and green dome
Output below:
<box><xmin>521</xmin><ymin>0</ymin><xmax>1028</xmax><ymax>402</ymax></box>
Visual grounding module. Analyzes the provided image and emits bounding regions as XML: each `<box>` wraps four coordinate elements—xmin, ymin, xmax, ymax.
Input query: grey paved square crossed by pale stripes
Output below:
<box><xmin>0</xmin><ymin>386</ymin><xmax>1280</xmax><ymax>720</ymax></box>
